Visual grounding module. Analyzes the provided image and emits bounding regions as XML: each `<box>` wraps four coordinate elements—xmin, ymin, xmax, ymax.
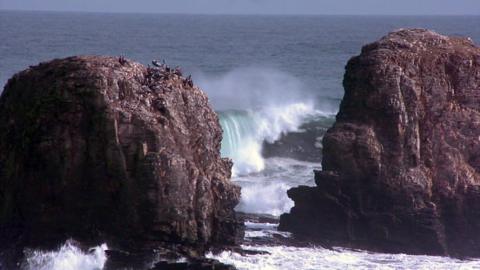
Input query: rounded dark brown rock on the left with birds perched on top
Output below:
<box><xmin>0</xmin><ymin>56</ymin><xmax>241</xmax><ymax>255</ymax></box>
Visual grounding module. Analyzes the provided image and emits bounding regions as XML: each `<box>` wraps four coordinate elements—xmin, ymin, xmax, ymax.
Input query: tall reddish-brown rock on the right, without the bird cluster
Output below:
<box><xmin>280</xmin><ymin>29</ymin><xmax>480</xmax><ymax>256</ymax></box>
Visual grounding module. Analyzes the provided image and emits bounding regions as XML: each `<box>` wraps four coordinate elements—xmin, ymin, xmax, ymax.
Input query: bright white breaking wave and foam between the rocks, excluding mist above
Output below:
<box><xmin>219</xmin><ymin>103</ymin><xmax>322</xmax><ymax>216</ymax></box>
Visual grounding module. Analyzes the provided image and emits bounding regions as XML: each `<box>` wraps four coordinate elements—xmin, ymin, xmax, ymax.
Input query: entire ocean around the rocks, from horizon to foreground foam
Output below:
<box><xmin>0</xmin><ymin>11</ymin><xmax>480</xmax><ymax>270</ymax></box>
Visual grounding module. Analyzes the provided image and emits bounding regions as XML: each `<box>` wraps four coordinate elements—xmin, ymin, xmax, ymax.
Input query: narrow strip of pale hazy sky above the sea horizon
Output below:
<box><xmin>0</xmin><ymin>0</ymin><xmax>480</xmax><ymax>15</ymax></box>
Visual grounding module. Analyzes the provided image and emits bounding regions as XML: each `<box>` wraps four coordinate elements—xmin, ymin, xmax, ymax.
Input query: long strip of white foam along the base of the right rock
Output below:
<box><xmin>207</xmin><ymin>246</ymin><xmax>480</xmax><ymax>270</ymax></box>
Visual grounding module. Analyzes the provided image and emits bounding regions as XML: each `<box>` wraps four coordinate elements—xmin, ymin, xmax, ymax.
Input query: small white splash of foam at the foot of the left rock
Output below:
<box><xmin>22</xmin><ymin>241</ymin><xmax>108</xmax><ymax>270</ymax></box>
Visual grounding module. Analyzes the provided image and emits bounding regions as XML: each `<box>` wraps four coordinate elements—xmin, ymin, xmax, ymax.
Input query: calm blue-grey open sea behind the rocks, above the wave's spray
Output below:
<box><xmin>0</xmin><ymin>11</ymin><xmax>480</xmax><ymax>98</ymax></box>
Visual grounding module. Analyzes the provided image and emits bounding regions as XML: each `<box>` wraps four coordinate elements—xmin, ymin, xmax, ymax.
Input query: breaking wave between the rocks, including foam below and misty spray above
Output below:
<box><xmin>193</xmin><ymin>66</ymin><xmax>326</xmax><ymax>215</ymax></box>
